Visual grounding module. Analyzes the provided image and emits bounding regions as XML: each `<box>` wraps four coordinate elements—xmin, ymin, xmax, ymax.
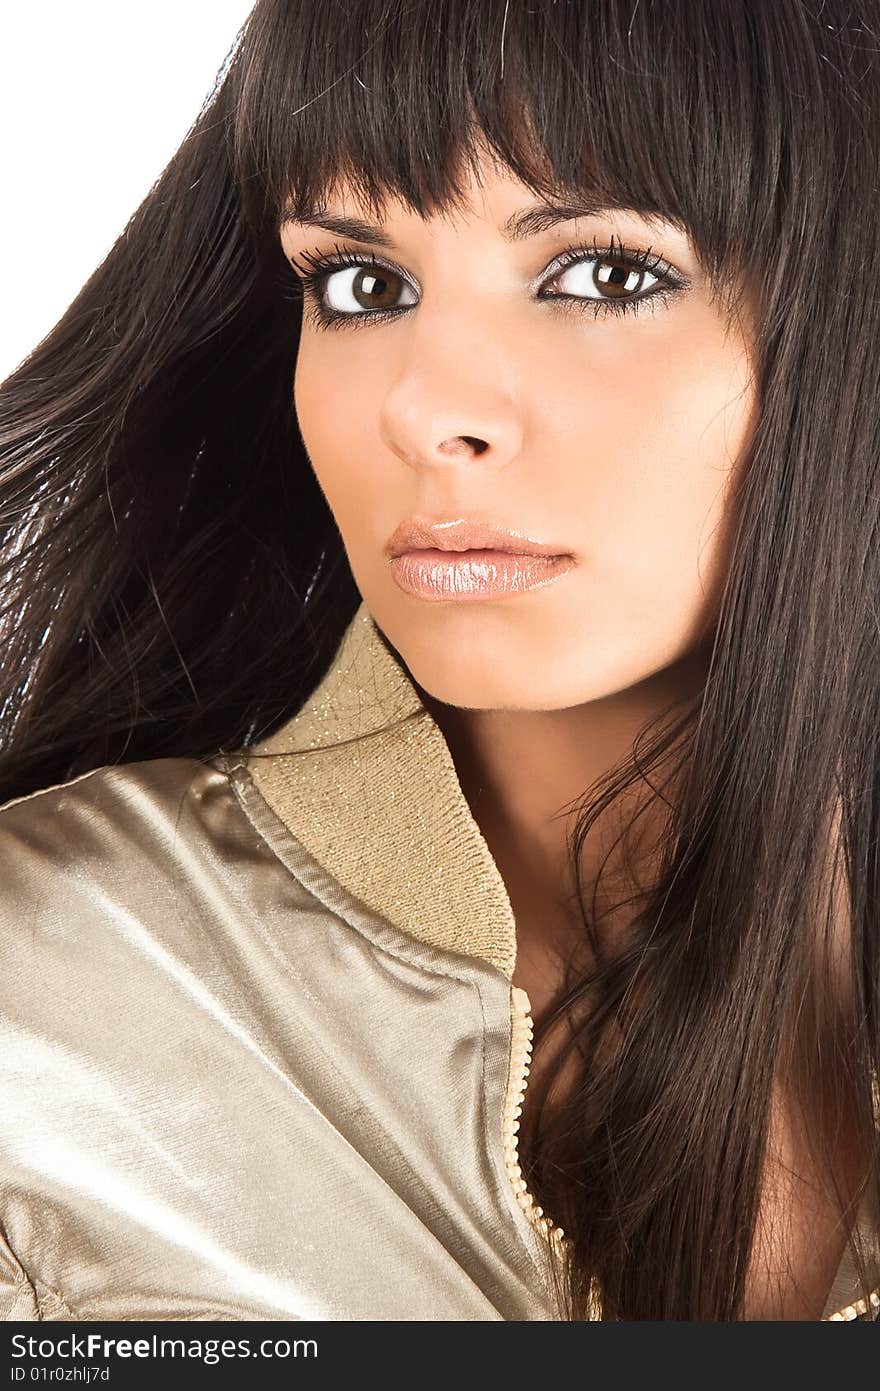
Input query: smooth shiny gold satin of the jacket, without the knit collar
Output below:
<box><xmin>0</xmin><ymin>759</ymin><xmax>548</xmax><ymax>1319</ymax></box>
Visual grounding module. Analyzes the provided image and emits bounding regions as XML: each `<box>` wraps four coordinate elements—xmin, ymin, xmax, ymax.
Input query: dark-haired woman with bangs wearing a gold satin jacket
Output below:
<box><xmin>0</xmin><ymin>0</ymin><xmax>880</xmax><ymax>1320</ymax></box>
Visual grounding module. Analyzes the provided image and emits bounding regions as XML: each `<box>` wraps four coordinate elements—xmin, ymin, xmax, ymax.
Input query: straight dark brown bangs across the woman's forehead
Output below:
<box><xmin>234</xmin><ymin>0</ymin><xmax>856</xmax><ymax>315</ymax></box>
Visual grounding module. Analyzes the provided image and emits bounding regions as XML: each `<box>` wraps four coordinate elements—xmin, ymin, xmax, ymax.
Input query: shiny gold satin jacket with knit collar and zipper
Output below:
<box><xmin>0</xmin><ymin>604</ymin><xmax>880</xmax><ymax>1320</ymax></box>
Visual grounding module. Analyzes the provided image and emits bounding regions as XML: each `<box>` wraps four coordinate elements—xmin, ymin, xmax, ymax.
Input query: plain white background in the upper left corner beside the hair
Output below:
<box><xmin>0</xmin><ymin>0</ymin><xmax>253</xmax><ymax>381</ymax></box>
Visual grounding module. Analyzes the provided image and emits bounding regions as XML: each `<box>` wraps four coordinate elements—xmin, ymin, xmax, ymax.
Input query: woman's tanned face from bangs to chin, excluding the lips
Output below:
<box><xmin>281</xmin><ymin>155</ymin><xmax>755</xmax><ymax>709</ymax></box>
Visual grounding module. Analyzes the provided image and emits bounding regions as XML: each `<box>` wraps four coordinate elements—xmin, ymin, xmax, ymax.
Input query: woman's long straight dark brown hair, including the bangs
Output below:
<box><xmin>0</xmin><ymin>0</ymin><xmax>880</xmax><ymax>1320</ymax></box>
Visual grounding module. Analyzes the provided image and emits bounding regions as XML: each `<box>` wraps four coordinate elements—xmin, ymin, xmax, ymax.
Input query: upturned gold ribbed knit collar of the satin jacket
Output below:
<box><xmin>247</xmin><ymin>602</ymin><xmax>516</xmax><ymax>981</ymax></box>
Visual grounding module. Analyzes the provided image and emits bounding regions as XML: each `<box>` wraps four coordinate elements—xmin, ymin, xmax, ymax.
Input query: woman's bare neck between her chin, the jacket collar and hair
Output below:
<box><xmin>417</xmin><ymin>650</ymin><xmax>706</xmax><ymax>995</ymax></box>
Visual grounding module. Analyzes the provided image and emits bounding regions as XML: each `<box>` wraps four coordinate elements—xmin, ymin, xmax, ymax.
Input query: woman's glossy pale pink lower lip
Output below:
<box><xmin>391</xmin><ymin>551</ymin><xmax>574</xmax><ymax>602</ymax></box>
